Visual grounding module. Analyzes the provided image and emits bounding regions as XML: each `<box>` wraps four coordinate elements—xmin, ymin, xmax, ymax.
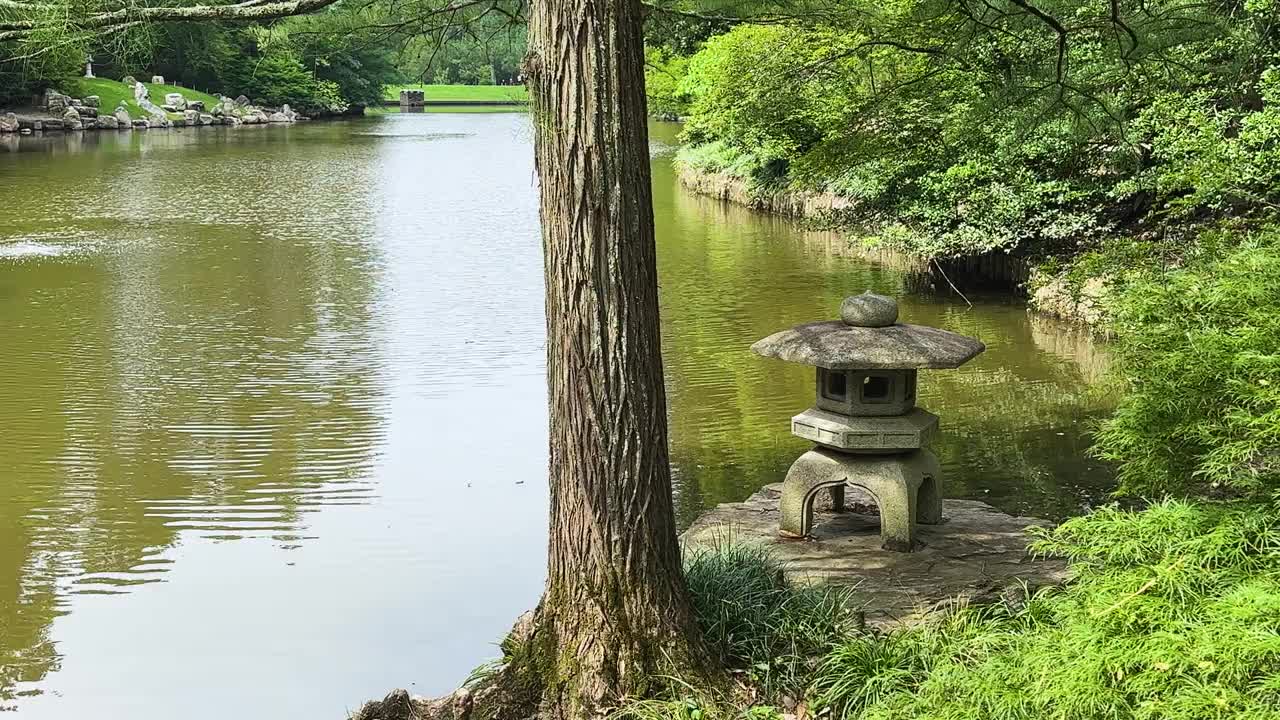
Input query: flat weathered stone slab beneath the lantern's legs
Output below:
<box><xmin>682</xmin><ymin>484</ymin><xmax>1066</xmax><ymax>629</ymax></box>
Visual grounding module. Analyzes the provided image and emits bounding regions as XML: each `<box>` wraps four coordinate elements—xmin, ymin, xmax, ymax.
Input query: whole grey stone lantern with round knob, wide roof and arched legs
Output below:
<box><xmin>751</xmin><ymin>293</ymin><xmax>986</xmax><ymax>551</ymax></box>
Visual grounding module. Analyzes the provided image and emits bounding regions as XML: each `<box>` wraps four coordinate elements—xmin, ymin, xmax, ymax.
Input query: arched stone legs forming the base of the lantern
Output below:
<box><xmin>780</xmin><ymin>447</ymin><xmax>942</xmax><ymax>552</ymax></box>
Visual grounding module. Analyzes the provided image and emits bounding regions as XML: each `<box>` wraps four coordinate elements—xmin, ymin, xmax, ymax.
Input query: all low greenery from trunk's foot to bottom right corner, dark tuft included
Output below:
<box><xmin>612</xmin><ymin>497</ymin><xmax>1280</xmax><ymax>720</ymax></box>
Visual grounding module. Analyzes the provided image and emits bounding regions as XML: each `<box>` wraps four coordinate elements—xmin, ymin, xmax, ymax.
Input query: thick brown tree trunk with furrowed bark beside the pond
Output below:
<box><xmin>516</xmin><ymin>0</ymin><xmax>713</xmax><ymax>717</ymax></box>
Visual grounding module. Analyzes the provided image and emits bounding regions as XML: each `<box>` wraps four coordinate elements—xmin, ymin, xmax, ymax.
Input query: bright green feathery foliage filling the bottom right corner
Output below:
<box><xmin>812</xmin><ymin>501</ymin><xmax>1280</xmax><ymax>720</ymax></box>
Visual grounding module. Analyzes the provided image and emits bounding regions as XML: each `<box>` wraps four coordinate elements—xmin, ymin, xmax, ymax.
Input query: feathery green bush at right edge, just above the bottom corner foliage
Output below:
<box><xmin>1097</xmin><ymin>229</ymin><xmax>1280</xmax><ymax>495</ymax></box>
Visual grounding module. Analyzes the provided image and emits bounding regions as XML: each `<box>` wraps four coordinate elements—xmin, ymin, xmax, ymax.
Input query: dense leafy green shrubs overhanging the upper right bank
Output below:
<box><xmin>665</xmin><ymin>0</ymin><xmax>1280</xmax><ymax>256</ymax></box>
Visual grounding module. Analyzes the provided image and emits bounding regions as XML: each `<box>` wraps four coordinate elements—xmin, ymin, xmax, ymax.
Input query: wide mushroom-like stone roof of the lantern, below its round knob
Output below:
<box><xmin>751</xmin><ymin>320</ymin><xmax>987</xmax><ymax>370</ymax></box>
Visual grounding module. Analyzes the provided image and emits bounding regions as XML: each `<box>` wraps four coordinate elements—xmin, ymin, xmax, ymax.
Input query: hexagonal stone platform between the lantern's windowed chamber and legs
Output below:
<box><xmin>791</xmin><ymin>407</ymin><xmax>938</xmax><ymax>452</ymax></box>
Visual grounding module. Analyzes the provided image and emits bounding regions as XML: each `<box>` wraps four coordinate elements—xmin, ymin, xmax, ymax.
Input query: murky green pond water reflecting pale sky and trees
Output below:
<box><xmin>0</xmin><ymin>113</ymin><xmax>1110</xmax><ymax>719</ymax></box>
